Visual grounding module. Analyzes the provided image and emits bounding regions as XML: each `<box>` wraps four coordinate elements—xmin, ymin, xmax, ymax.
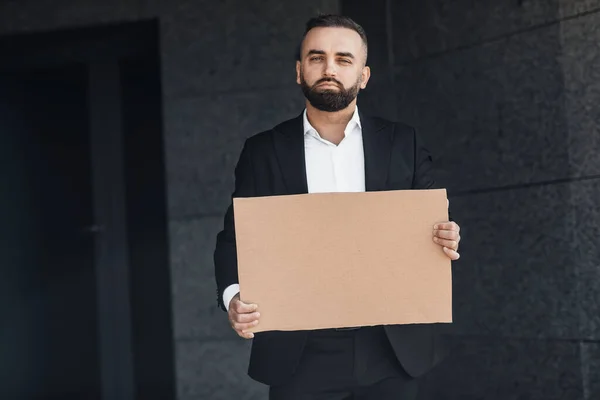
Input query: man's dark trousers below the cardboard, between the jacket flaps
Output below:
<box><xmin>269</xmin><ymin>327</ymin><xmax>418</xmax><ymax>400</ymax></box>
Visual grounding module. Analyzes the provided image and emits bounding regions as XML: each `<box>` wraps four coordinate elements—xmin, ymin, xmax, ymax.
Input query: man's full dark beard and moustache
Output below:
<box><xmin>300</xmin><ymin>74</ymin><xmax>360</xmax><ymax>112</ymax></box>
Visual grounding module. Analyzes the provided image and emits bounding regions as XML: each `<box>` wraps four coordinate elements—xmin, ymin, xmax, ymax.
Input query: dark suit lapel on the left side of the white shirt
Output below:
<box><xmin>273</xmin><ymin>114</ymin><xmax>308</xmax><ymax>194</ymax></box>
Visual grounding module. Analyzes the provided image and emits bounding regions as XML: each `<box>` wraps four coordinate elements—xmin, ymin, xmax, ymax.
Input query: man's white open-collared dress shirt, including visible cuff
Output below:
<box><xmin>223</xmin><ymin>107</ymin><xmax>365</xmax><ymax>310</ymax></box>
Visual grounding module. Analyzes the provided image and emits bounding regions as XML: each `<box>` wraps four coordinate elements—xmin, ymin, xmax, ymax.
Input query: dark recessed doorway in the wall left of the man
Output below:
<box><xmin>0</xmin><ymin>21</ymin><xmax>174</xmax><ymax>400</ymax></box>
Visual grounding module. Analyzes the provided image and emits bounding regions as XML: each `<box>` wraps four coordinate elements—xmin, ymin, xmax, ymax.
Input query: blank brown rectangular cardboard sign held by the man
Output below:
<box><xmin>234</xmin><ymin>189</ymin><xmax>452</xmax><ymax>332</ymax></box>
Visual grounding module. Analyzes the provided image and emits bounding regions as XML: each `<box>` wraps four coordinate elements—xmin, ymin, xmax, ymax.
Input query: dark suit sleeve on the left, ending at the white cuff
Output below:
<box><xmin>214</xmin><ymin>141</ymin><xmax>255</xmax><ymax>311</ymax></box>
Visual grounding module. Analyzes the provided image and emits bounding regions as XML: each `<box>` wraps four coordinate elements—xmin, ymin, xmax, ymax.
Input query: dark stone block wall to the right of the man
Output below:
<box><xmin>342</xmin><ymin>0</ymin><xmax>600</xmax><ymax>400</ymax></box>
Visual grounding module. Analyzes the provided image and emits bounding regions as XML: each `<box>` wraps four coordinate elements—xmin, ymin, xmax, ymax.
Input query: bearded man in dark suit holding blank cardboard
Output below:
<box><xmin>214</xmin><ymin>15</ymin><xmax>460</xmax><ymax>400</ymax></box>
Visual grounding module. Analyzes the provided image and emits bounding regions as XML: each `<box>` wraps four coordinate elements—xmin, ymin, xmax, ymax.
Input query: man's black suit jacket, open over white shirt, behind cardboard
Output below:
<box><xmin>214</xmin><ymin>113</ymin><xmax>450</xmax><ymax>385</ymax></box>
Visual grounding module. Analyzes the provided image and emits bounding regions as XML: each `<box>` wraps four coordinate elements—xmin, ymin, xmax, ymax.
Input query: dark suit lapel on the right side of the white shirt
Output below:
<box><xmin>359</xmin><ymin>110</ymin><xmax>393</xmax><ymax>191</ymax></box>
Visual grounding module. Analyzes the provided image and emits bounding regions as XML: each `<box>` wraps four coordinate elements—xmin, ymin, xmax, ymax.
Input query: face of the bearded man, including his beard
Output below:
<box><xmin>296</xmin><ymin>28</ymin><xmax>370</xmax><ymax>112</ymax></box>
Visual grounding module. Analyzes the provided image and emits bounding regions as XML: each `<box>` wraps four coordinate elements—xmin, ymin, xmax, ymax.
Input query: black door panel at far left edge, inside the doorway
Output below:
<box><xmin>0</xmin><ymin>64</ymin><xmax>101</xmax><ymax>399</ymax></box>
